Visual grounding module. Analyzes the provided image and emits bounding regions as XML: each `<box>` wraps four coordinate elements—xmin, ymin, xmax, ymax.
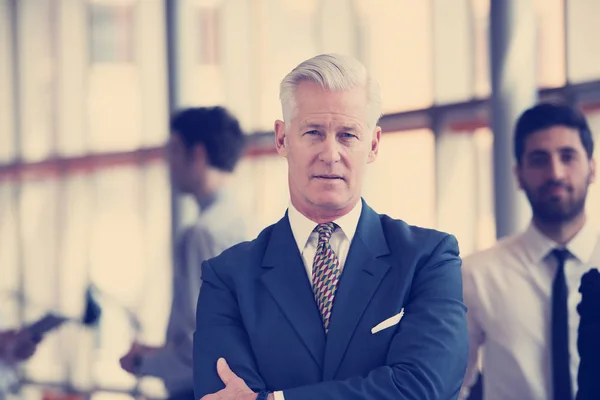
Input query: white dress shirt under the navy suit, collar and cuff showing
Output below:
<box><xmin>274</xmin><ymin>201</ymin><xmax>362</xmax><ymax>400</ymax></box>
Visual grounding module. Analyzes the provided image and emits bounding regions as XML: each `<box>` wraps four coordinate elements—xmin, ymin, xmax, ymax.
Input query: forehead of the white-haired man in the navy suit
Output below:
<box><xmin>294</xmin><ymin>82</ymin><xmax>367</xmax><ymax>126</ymax></box>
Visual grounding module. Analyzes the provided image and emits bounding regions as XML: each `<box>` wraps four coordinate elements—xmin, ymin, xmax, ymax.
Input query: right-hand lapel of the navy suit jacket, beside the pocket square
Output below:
<box><xmin>323</xmin><ymin>203</ymin><xmax>390</xmax><ymax>380</ymax></box>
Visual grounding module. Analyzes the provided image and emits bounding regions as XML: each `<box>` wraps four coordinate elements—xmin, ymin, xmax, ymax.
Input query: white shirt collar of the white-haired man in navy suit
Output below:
<box><xmin>288</xmin><ymin>201</ymin><xmax>362</xmax><ymax>252</ymax></box>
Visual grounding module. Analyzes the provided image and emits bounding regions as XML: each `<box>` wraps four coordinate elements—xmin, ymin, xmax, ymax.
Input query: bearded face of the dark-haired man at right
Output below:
<box><xmin>516</xmin><ymin>126</ymin><xmax>595</xmax><ymax>223</ymax></box>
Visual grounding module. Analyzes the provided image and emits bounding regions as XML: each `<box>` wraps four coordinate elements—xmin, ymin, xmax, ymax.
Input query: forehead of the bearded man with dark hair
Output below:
<box><xmin>525</xmin><ymin>125</ymin><xmax>585</xmax><ymax>154</ymax></box>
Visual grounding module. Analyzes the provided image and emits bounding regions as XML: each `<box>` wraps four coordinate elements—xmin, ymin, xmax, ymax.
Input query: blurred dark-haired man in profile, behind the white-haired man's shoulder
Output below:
<box><xmin>120</xmin><ymin>107</ymin><xmax>246</xmax><ymax>400</ymax></box>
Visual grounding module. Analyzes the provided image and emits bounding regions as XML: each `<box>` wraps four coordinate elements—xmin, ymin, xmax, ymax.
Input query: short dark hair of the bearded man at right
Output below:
<box><xmin>514</xmin><ymin>103</ymin><xmax>594</xmax><ymax>164</ymax></box>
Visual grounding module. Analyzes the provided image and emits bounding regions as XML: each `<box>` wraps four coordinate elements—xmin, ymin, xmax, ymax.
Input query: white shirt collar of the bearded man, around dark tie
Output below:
<box><xmin>523</xmin><ymin>217</ymin><xmax>598</xmax><ymax>264</ymax></box>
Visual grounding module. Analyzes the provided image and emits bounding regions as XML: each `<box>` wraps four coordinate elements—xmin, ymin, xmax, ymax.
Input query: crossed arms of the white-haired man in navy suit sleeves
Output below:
<box><xmin>194</xmin><ymin>235</ymin><xmax>468</xmax><ymax>400</ymax></box>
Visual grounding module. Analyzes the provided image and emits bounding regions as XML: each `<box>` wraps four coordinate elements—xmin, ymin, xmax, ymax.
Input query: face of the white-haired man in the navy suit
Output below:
<box><xmin>275</xmin><ymin>82</ymin><xmax>381</xmax><ymax>214</ymax></box>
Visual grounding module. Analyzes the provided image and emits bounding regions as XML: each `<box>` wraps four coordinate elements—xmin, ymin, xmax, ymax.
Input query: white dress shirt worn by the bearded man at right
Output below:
<box><xmin>460</xmin><ymin>223</ymin><xmax>600</xmax><ymax>400</ymax></box>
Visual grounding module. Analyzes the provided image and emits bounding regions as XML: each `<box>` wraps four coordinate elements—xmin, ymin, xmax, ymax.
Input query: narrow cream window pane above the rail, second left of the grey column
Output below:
<box><xmin>433</xmin><ymin>0</ymin><xmax>475</xmax><ymax>103</ymax></box>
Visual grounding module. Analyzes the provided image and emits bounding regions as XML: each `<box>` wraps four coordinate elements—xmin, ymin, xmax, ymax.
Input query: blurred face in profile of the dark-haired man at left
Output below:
<box><xmin>166</xmin><ymin>133</ymin><xmax>201</xmax><ymax>194</ymax></box>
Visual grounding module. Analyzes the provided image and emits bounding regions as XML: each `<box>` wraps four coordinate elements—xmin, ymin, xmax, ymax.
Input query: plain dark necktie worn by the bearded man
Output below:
<box><xmin>551</xmin><ymin>249</ymin><xmax>573</xmax><ymax>400</ymax></box>
